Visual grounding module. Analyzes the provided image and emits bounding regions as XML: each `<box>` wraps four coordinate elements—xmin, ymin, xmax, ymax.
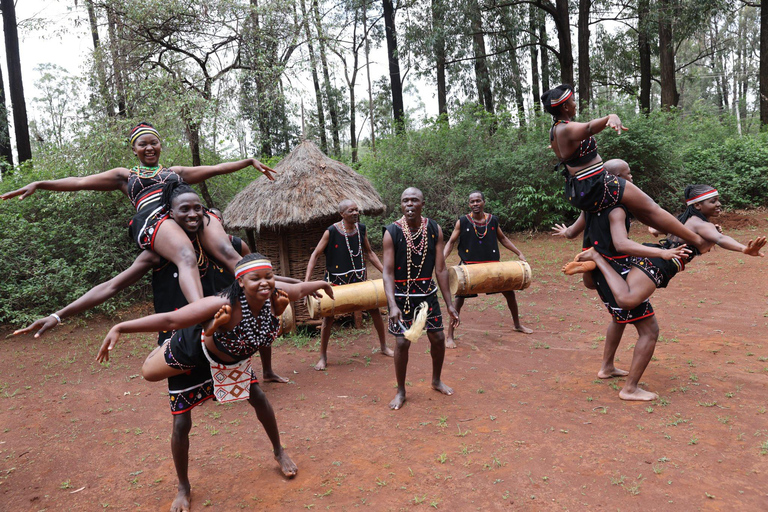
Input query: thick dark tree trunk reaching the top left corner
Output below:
<box><xmin>0</xmin><ymin>0</ymin><xmax>32</xmax><ymax>163</ymax></box>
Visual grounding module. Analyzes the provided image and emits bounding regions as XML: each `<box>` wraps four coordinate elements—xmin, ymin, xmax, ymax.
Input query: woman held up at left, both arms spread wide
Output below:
<box><xmin>0</xmin><ymin>123</ymin><xmax>275</xmax><ymax>303</ymax></box>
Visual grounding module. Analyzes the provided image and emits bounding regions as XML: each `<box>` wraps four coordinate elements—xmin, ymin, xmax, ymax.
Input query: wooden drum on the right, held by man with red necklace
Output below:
<box><xmin>448</xmin><ymin>261</ymin><xmax>531</xmax><ymax>295</ymax></box>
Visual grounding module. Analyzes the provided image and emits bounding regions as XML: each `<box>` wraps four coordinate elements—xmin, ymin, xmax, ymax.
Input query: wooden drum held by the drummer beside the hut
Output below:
<box><xmin>307</xmin><ymin>279</ymin><xmax>387</xmax><ymax>319</ymax></box>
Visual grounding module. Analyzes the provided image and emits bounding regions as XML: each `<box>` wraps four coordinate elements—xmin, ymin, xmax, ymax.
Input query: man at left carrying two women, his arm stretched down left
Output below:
<box><xmin>14</xmin><ymin>187</ymin><xmax>299</xmax><ymax>512</ymax></box>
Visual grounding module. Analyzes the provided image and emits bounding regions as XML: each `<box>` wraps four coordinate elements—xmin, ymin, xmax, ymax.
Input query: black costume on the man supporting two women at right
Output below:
<box><xmin>582</xmin><ymin>205</ymin><xmax>655</xmax><ymax>324</ymax></box>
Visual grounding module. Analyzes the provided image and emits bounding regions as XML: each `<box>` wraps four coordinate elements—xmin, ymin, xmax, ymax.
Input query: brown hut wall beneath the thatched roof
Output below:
<box><xmin>256</xmin><ymin>221</ymin><xmax>332</xmax><ymax>324</ymax></box>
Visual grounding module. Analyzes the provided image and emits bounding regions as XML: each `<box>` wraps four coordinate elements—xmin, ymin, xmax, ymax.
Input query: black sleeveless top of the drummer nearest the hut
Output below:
<box><xmin>325</xmin><ymin>223</ymin><xmax>366</xmax><ymax>285</ymax></box>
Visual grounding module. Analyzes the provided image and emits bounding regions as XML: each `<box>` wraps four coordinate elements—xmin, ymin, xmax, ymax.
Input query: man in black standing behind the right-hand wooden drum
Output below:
<box><xmin>443</xmin><ymin>190</ymin><xmax>533</xmax><ymax>348</ymax></box>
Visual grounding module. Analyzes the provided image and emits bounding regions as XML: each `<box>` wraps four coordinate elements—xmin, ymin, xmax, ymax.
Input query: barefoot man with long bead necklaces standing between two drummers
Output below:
<box><xmin>383</xmin><ymin>187</ymin><xmax>459</xmax><ymax>409</ymax></box>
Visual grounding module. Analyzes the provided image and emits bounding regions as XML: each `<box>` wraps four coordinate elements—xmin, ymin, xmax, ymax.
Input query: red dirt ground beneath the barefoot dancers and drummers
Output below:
<box><xmin>0</xmin><ymin>211</ymin><xmax>768</xmax><ymax>511</ymax></box>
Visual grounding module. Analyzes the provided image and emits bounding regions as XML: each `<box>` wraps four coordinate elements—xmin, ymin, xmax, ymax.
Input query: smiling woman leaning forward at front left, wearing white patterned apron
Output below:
<box><xmin>96</xmin><ymin>253</ymin><xmax>333</xmax><ymax>503</ymax></box>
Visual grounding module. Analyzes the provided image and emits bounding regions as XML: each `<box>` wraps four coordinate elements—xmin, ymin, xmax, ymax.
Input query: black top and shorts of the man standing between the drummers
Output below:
<box><xmin>384</xmin><ymin>218</ymin><xmax>443</xmax><ymax>336</ymax></box>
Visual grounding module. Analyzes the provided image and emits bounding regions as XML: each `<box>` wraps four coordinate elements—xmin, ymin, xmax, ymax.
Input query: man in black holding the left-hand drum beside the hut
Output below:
<box><xmin>304</xmin><ymin>199</ymin><xmax>395</xmax><ymax>370</ymax></box>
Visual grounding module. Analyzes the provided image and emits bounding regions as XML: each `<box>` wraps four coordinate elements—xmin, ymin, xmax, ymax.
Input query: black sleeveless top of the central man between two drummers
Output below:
<box><xmin>384</xmin><ymin>217</ymin><xmax>439</xmax><ymax>297</ymax></box>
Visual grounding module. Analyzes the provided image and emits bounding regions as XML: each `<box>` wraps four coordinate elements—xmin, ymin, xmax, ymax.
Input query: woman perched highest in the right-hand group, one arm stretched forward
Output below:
<box><xmin>541</xmin><ymin>84</ymin><xmax>704</xmax><ymax>247</ymax></box>
